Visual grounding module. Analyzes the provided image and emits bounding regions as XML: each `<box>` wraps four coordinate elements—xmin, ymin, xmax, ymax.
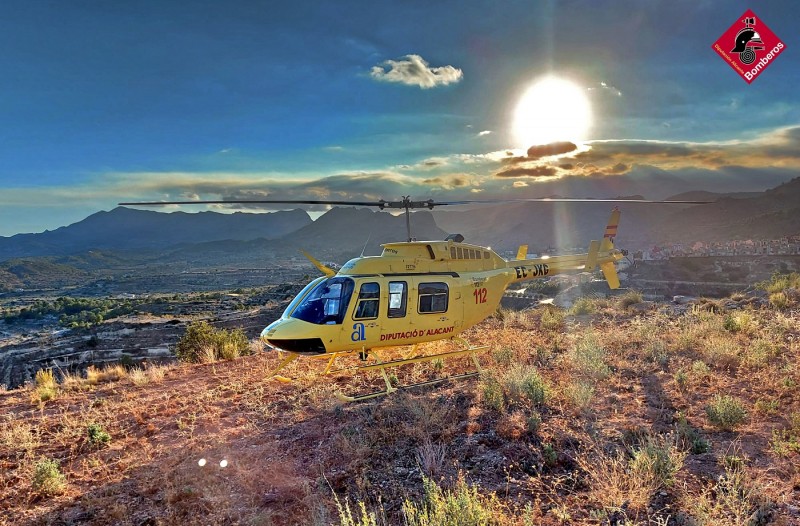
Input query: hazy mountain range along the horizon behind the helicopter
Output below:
<box><xmin>0</xmin><ymin>178</ymin><xmax>800</xmax><ymax>264</ymax></box>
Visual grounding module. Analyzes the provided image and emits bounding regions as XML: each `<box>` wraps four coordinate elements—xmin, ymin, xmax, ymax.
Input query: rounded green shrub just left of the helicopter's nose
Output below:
<box><xmin>175</xmin><ymin>321</ymin><xmax>251</xmax><ymax>363</ymax></box>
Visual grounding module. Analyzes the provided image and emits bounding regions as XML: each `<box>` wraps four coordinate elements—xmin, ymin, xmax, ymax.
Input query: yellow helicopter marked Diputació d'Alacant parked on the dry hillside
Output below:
<box><xmin>120</xmin><ymin>196</ymin><xmax>701</xmax><ymax>401</ymax></box>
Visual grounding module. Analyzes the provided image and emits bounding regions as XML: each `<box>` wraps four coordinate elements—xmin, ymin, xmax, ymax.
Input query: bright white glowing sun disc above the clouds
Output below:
<box><xmin>513</xmin><ymin>77</ymin><xmax>592</xmax><ymax>148</ymax></box>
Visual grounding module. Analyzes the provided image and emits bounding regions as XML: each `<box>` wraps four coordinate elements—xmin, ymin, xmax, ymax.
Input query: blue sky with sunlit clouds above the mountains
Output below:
<box><xmin>0</xmin><ymin>0</ymin><xmax>800</xmax><ymax>236</ymax></box>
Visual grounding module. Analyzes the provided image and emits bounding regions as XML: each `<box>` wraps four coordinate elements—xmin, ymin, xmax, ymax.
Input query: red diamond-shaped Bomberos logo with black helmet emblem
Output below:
<box><xmin>711</xmin><ymin>9</ymin><xmax>786</xmax><ymax>84</ymax></box>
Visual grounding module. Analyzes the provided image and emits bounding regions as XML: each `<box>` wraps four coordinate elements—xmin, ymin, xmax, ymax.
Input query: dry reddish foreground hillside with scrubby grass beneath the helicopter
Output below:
<box><xmin>0</xmin><ymin>295</ymin><xmax>800</xmax><ymax>526</ymax></box>
